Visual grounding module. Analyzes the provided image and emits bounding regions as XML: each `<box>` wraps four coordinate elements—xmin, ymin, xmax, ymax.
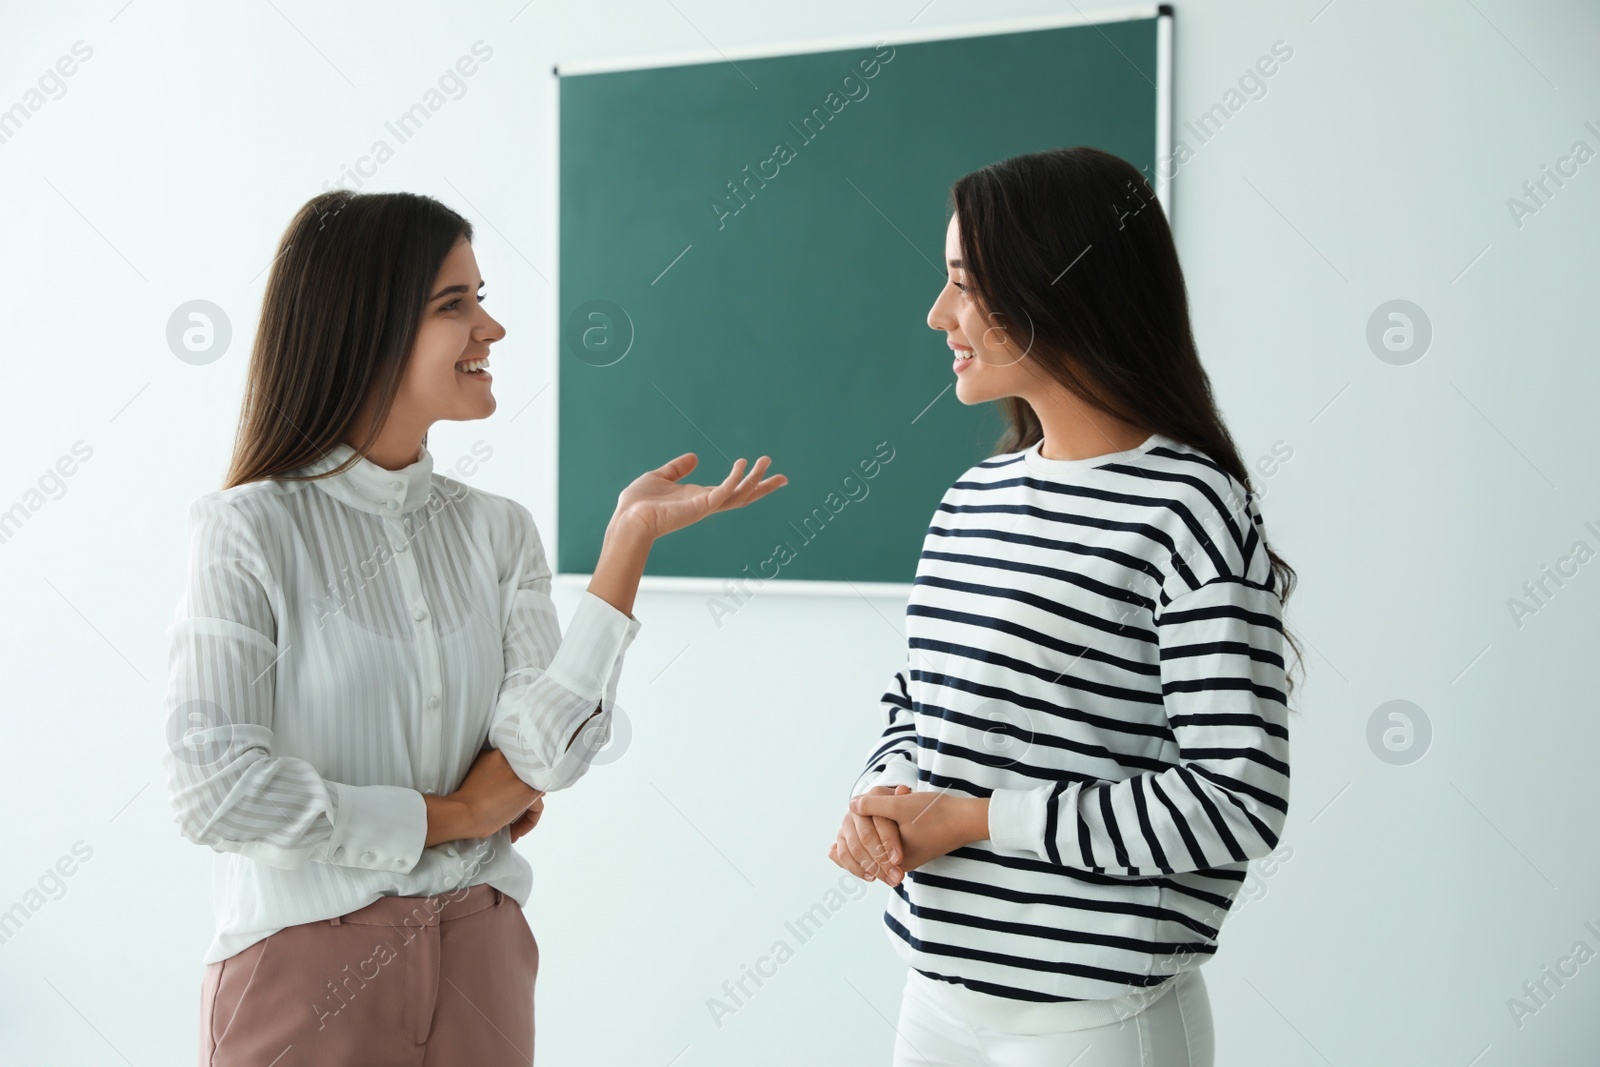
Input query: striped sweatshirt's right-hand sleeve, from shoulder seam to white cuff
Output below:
<box><xmin>987</xmin><ymin>576</ymin><xmax>1290</xmax><ymax>877</ymax></box>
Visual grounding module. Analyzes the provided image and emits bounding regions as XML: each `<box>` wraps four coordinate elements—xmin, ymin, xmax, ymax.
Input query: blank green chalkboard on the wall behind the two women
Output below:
<box><xmin>555</xmin><ymin>10</ymin><xmax>1165</xmax><ymax>582</ymax></box>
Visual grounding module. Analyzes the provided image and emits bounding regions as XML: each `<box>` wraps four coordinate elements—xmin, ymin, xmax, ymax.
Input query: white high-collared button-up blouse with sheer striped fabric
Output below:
<box><xmin>162</xmin><ymin>443</ymin><xmax>640</xmax><ymax>963</ymax></box>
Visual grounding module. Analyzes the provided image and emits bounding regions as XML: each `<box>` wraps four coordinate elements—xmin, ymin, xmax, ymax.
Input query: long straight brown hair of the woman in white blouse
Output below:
<box><xmin>222</xmin><ymin>189</ymin><xmax>472</xmax><ymax>488</ymax></box>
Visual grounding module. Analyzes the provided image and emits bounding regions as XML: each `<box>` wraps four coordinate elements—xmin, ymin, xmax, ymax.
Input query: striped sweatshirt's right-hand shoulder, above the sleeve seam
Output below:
<box><xmin>1142</xmin><ymin>438</ymin><xmax>1275</xmax><ymax>597</ymax></box>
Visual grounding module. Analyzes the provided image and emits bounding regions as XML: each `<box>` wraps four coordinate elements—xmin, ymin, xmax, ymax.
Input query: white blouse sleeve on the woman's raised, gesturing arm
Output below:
<box><xmin>490</xmin><ymin>501</ymin><xmax>640</xmax><ymax>792</ymax></box>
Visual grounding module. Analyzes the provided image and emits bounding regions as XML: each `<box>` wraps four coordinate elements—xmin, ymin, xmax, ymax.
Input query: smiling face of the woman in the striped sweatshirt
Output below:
<box><xmin>928</xmin><ymin>214</ymin><xmax>1040</xmax><ymax>405</ymax></box>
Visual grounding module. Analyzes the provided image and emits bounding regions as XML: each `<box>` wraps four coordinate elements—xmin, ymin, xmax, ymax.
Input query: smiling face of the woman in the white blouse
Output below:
<box><xmin>390</xmin><ymin>237</ymin><xmax>506</xmax><ymax>432</ymax></box>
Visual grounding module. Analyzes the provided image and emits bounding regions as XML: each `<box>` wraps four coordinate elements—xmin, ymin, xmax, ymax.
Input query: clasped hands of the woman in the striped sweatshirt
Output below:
<box><xmin>827</xmin><ymin>785</ymin><xmax>989</xmax><ymax>886</ymax></box>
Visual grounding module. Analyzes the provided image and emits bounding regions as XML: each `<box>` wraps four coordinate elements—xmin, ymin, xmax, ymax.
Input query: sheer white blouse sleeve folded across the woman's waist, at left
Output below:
<box><xmin>162</xmin><ymin>498</ymin><xmax>427</xmax><ymax>870</ymax></box>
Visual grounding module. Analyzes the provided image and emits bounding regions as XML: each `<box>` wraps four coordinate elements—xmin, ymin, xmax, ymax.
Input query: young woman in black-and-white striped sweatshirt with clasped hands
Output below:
<box><xmin>829</xmin><ymin>147</ymin><xmax>1298</xmax><ymax>1067</ymax></box>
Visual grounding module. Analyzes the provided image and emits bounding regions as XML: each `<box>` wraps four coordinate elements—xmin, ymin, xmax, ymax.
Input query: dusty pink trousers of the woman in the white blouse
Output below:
<box><xmin>200</xmin><ymin>885</ymin><xmax>539</xmax><ymax>1067</ymax></box>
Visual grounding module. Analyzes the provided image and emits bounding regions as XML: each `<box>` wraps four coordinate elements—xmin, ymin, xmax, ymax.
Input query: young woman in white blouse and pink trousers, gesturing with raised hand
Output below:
<box><xmin>163</xmin><ymin>190</ymin><xmax>786</xmax><ymax>1067</ymax></box>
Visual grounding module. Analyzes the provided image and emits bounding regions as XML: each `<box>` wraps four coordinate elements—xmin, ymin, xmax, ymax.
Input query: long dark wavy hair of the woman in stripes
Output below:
<box><xmin>950</xmin><ymin>146</ymin><xmax>1301</xmax><ymax>694</ymax></box>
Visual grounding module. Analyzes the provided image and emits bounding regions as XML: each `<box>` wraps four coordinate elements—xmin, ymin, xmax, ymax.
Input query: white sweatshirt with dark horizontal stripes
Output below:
<box><xmin>853</xmin><ymin>434</ymin><xmax>1290</xmax><ymax>1029</ymax></box>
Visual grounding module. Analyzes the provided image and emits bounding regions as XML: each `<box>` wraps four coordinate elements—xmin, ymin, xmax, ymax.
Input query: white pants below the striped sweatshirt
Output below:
<box><xmin>894</xmin><ymin>968</ymin><xmax>1214</xmax><ymax>1067</ymax></box>
